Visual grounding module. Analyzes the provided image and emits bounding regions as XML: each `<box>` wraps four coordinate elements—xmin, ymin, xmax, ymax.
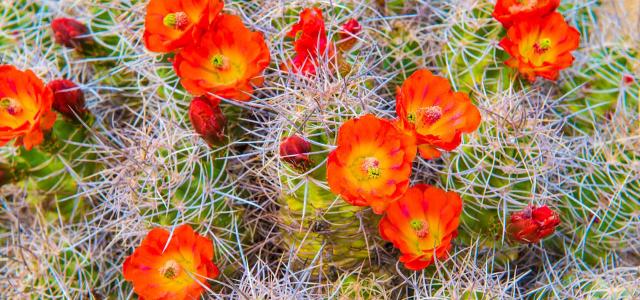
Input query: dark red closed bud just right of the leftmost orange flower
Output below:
<box><xmin>47</xmin><ymin>79</ymin><xmax>87</xmax><ymax>119</ymax></box>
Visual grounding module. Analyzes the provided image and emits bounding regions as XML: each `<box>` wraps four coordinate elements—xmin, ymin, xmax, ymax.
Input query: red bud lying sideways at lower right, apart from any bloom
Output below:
<box><xmin>507</xmin><ymin>205</ymin><xmax>560</xmax><ymax>244</ymax></box>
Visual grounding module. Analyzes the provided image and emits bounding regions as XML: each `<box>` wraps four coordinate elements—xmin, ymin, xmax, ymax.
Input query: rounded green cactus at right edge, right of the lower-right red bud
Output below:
<box><xmin>561</xmin><ymin>124</ymin><xmax>640</xmax><ymax>266</ymax></box>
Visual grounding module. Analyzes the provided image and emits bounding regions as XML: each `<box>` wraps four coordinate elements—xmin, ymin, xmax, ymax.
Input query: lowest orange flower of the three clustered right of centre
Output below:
<box><xmin>379</xmin><ymin>184</ymin><xmax>462</xmax><ymax>270</ymax></box>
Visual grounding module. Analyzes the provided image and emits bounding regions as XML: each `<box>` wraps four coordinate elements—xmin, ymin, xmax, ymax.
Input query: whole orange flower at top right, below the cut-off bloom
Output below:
<box><xmin>500</xmin><ymin>13</ymin><xmax>580</xmax><ymax>82</ymax></box>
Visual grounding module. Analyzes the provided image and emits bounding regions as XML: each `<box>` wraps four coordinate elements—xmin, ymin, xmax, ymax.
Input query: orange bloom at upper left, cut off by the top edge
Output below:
<box><xmin>144</xmin><ymin>0</ymin><xmax>224</xmax><ymax>52</ymax></box>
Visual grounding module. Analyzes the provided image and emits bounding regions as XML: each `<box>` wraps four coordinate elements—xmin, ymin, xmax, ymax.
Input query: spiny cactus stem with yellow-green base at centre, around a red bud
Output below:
<box><xmin>251</xmin><ymin>53</ymin><xmax>390</xmax><ymax>279</ymax></box>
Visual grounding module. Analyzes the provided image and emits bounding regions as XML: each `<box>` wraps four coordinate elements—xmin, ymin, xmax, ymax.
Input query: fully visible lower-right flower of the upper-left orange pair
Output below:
<box><xmin>173</xmin><ymin>14</ymin><xmax>270</xmax><ymax>101</ymax></box>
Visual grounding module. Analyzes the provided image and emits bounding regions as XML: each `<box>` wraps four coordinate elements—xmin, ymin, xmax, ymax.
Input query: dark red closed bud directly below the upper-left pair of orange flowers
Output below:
<box><xmin>189</xmin><ymin>97</ymin><xmax>227</xmax><ymax>145</ymax></box>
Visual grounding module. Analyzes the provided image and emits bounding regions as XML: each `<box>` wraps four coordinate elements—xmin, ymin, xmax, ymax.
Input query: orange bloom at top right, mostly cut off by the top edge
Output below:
<box><xmin>493</xmin><ymin>0</ymin><xmax>560</xmax><ymax>28</ymax></box>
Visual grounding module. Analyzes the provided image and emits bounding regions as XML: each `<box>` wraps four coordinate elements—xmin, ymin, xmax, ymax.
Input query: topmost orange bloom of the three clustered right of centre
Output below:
<box><xmin>396</xmin><ymin>70</ymin><xmax>480</xmax><ymax>159</ymax></box>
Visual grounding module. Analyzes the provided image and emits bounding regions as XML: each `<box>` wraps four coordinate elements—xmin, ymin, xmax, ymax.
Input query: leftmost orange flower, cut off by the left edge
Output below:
<box><xmin>0</xmin><ymin>65</ymin><xmax>56</xmax><ymax>150</ymax></box>
